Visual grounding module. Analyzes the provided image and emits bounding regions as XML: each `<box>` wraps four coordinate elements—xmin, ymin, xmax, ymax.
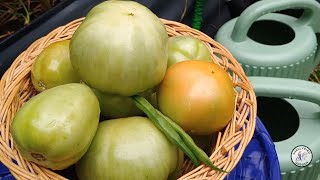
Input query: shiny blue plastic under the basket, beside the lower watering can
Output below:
<box><xmin>225</xmin><ymin>117</ymin><xmax>281</xmax><ymax>180</ymax></box>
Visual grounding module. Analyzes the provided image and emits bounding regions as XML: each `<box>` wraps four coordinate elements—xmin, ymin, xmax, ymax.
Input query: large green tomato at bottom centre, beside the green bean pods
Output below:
<box><xmin>76</xmin><ymin>116</ymin><xmax>183</xmax><ymax>180</ymax></box>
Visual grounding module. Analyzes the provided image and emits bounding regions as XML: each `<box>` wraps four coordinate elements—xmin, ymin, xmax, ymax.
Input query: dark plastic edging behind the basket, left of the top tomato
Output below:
<box><xmin>0</xmin><ymin>0</ymin><xmax>101</xmax><ymax>77</ymax></box>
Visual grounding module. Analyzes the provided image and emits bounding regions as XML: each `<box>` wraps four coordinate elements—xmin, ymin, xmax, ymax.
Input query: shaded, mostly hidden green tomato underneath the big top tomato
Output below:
<box><xmin>92</xmin><ymin>89</ymin><xmax>157</xmax><ymax>119</ymax></box>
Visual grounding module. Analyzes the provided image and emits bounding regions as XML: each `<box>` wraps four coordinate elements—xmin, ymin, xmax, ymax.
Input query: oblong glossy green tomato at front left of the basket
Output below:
<box><xmin>11</xmin><ymin>83</ymin><xmax>100</xmax><ymax>170</ymax></box>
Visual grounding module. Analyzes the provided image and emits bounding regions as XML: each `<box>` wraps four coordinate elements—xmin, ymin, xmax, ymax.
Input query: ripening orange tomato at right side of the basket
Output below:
<box><xmin>157</xmin><ymin>60</ymin><xmax>236</xmax><ymax>135</ymax></box>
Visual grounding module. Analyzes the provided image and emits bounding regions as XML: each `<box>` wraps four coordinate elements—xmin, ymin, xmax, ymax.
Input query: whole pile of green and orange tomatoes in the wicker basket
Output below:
<box><xmin>11</xmin><ymin>1</ymin><xmax>236</xmax><ymax>180</ymax></box>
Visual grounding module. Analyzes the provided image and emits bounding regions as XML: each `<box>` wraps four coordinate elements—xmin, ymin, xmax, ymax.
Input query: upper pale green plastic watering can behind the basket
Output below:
<box><xmin>215</xmin><ymin>0</ymin><xmax>320</xmax><ymax>80</ymax></box>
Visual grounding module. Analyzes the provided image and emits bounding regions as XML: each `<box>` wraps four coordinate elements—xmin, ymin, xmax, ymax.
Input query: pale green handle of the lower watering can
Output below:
<box><xmin>249</xmin><ymin>76</ymin><xmax>320</xmax><ymax>105</ymax></box>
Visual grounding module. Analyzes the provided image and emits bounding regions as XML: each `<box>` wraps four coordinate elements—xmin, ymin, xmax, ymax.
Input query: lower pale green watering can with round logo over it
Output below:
<box><xmin>249</xmin><ymin>76</ymin><xmax>320</xmax><ymax>180</ymax></box>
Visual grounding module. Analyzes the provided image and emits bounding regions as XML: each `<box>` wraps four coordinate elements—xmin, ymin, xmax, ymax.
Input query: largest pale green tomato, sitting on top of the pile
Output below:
<box><xmin>70</xmin><ymin>1</ymin><xmax>168</xmax><ymax>96</ymax></box>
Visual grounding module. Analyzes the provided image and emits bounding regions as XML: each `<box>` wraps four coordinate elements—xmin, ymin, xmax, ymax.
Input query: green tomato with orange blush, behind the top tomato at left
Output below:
<box><xmin>31</xmin><ymin>40</ymin><xmax>80</xmax><ymax>92</ymax></box>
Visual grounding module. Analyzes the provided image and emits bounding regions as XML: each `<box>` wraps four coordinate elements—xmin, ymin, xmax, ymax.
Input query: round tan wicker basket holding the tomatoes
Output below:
<box><xmin>0</xmin><ymin>18</ymin><xmax>256</xmax><ymax>180</ymax></box>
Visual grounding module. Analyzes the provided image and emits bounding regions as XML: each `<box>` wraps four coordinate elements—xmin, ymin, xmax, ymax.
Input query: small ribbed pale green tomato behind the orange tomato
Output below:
<box><xmin>168</xmin><ymin>35</ymin><xmax>212</xmax><ymax>67</ymax></box>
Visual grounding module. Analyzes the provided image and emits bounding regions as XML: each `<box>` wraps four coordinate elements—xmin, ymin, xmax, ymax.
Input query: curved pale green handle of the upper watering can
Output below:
<box><xmin>231</xmin><ymin>0</ymin><xmax>320</xmax><ymax>42</ymax></box>
